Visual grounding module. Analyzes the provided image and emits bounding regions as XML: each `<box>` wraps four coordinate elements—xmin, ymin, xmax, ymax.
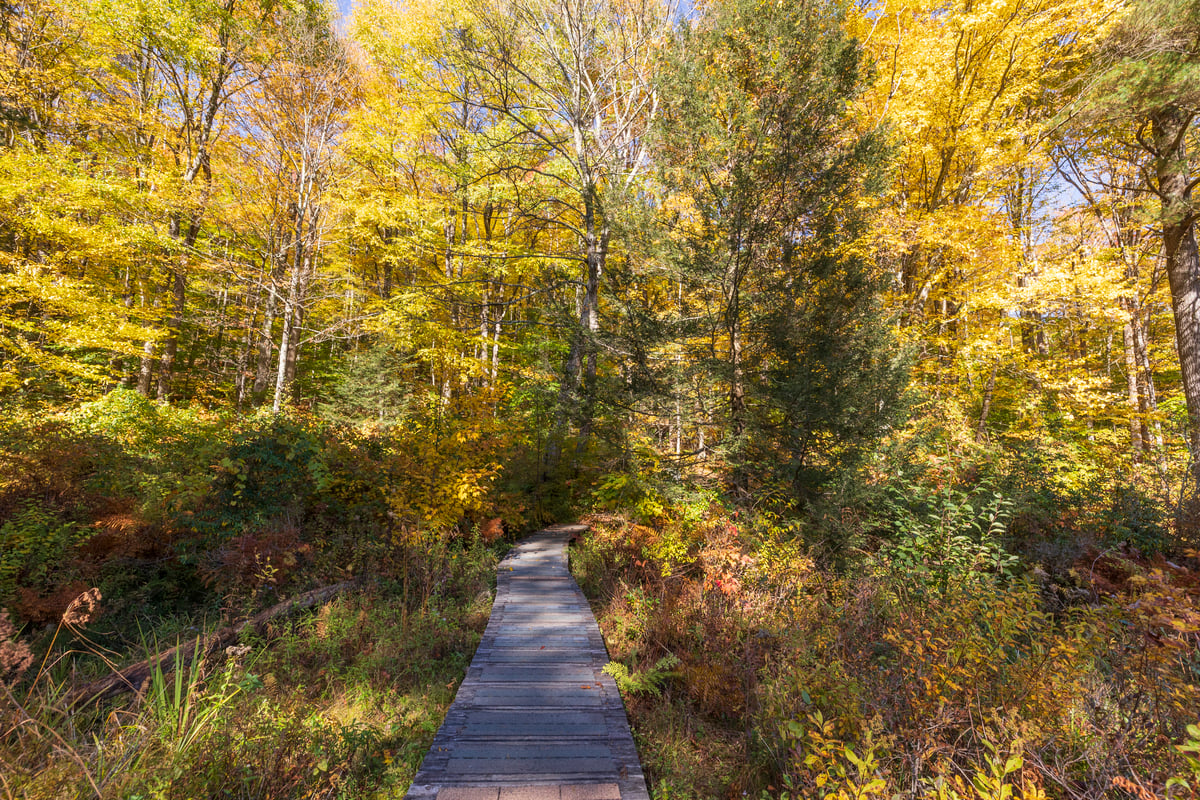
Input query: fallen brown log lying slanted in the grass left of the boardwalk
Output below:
<box><xmin>67</xmin><ymin>581</ymin><xmax>355</xmax><ymax>706</ymax></box>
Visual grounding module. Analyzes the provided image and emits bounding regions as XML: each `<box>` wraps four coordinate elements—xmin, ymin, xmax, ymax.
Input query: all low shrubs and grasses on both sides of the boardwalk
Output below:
<box><xmin>0</xmin><ymin>391</ymin><xmax>1200</xmax><ymax>800</ymax></box>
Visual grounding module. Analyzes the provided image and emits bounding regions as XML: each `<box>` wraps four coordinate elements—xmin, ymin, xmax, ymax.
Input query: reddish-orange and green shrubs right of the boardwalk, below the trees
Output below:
<box><xmin>571</xmin><ymin>447</ymin><xmax>1200</xmax><ymax>800</ymax></box>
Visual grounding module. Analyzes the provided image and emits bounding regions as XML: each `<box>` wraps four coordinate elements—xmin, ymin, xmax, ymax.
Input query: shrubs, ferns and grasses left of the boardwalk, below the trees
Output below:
<box><xmin>0</xmin><ymin>392</ymin><xmax>505</xmax><ymax>800</ymax></box>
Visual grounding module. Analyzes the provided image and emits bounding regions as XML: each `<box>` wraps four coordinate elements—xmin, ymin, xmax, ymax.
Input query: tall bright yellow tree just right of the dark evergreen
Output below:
<box><xmin>852</xmin><ymin>0</ymin><xmax>1122</xmax><ymax>438</ymax></box>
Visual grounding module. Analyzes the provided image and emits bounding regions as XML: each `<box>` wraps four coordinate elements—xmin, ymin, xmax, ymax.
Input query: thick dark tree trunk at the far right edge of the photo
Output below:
<box><xmin>1151</xmin><ymin>106</ymin><xmax>1200</xmax><ymax>493</ymax></box>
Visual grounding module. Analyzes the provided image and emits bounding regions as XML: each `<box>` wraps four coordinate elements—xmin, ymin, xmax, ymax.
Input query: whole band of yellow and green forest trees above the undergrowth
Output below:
<box><xmin>0</xmin><ymin>0</ymin><xmax>1200</xmax><ymax>510</ymax></box>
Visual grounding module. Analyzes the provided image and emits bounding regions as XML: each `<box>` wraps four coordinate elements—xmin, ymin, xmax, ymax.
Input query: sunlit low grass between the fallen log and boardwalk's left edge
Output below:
<box><xmin>0</xmin><ymin>527</ymin><xmax>497</xmax><ymax>800</ymax></box>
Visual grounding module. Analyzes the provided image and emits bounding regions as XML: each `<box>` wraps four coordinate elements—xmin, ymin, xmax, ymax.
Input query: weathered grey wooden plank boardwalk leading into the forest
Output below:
<box><xmin>406</xmin><ymin>525</ymin><xmax>649</xmax><ymax>800</ymax></box>
